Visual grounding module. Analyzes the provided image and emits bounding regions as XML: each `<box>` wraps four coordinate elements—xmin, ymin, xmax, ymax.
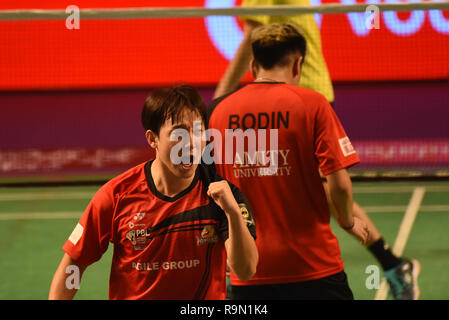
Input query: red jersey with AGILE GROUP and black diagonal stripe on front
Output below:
<box><xmin>63</xmin><ymin>162</ymin><xmax>255</xmax><ymax>300</ymax></box>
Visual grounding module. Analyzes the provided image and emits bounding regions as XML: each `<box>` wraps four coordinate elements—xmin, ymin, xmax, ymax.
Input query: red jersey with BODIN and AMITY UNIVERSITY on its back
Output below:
<box><xmin>208</xmin><ymin>82</ymin><xmax>359</xmax><ymax>285</ymax></box>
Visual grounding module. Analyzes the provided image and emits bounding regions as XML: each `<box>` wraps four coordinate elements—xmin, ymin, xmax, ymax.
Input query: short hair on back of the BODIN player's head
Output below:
<box><xmin>251</xmin><ymin>23</ymin><xmax>306</xmax><ymax>70</ymax></box>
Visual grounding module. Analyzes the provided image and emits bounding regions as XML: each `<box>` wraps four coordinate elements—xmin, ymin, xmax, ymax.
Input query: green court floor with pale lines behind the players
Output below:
<box><xmin>0</xmin><ymin>182</ymin><xmax>449</xmax><ymax>300</ymax></box>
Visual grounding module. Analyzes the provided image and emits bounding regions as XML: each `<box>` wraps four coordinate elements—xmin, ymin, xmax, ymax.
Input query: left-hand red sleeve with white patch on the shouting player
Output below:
<box><xmin>63</xmin><ymin>186</ymin><xmax>114</xmax><ymax>266</ymax></box>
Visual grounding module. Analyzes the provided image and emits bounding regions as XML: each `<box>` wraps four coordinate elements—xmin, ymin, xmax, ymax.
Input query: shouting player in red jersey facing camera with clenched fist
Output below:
<box><xmin>49</xmin><ymin>86</ymin><xmax>258</xmax><ymax>300</ymax></box>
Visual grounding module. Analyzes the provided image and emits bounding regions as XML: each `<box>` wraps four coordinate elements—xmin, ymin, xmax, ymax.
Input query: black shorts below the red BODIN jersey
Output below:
<box><xmin>230</xmin><ymin>271</ymin><xmax>354</xmax><ymax>300</ymax></box>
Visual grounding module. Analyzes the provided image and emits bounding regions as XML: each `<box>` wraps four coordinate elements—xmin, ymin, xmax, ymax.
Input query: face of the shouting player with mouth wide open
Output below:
<box><xmin>157</xmin><ymin>110</ymin><xmax>206</xmax><ymax>178</ymax></box>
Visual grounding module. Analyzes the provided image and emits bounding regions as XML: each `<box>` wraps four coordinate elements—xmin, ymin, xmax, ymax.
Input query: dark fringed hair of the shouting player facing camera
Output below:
<box><xmin>141</xmin><ymin>84</ymin><xmax>206</xmax><ymax>135</ymax></box>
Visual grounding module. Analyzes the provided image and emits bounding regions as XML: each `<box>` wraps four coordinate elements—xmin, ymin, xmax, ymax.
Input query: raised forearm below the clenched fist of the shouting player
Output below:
<box><xmin>226</xmin><ymin>206</ymin><xmax>259</xmax><ymax>281</ymax></box>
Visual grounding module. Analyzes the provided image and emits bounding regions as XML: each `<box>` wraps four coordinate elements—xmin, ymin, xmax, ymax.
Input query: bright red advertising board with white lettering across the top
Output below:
<box><xmin>0</xmin><ymin>0</ymin><xmax>449</xmax><ymax>90</ymax></box>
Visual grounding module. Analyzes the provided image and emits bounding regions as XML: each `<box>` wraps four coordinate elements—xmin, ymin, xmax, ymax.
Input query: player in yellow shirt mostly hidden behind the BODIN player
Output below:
<box><xmin>214</xmin><ymin>0</ymin><xmax>421</xmax><ymax>300</ymax></box>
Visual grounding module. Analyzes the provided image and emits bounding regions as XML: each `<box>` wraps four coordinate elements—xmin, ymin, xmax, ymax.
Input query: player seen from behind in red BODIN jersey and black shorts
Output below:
<box><xmin>208</xmin><ymin>24</ymin><xmax>368</xmax><ymax>299</ymax></box>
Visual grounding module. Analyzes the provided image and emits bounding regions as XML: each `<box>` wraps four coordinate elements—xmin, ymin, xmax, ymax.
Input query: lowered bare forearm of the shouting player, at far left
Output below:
<box><xmin>48</xmin><ymin>254</ymin><xmax>84</xmax><ymax>300</ymax></box>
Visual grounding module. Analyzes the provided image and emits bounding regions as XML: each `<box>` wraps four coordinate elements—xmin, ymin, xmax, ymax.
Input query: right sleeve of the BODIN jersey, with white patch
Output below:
<box><xmin>315</xmin><ymin>97</ymin><xmax>360</xmax><ymax>175</ymax></box>
